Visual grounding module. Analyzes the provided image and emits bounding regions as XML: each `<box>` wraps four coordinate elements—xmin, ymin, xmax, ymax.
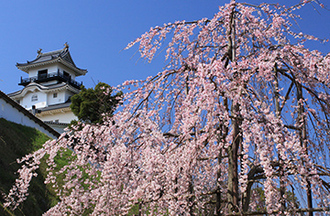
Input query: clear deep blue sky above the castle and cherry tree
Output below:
<box><xmin>0</xmin><ymin>0</ymin><xmax>330</xmax><ymax>93</ymax></box>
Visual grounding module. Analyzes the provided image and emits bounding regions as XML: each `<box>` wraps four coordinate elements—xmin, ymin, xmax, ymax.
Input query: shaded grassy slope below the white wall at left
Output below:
<box><xmin>0</xmin><ymin>118</ymin><xmax>56</xmax><ymax>215</ymax></box>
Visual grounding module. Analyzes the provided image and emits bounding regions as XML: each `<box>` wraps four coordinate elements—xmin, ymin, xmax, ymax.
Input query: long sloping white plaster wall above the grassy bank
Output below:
<box><xmin>0</xmin><ymin>98</ymin><xmax>56</xmax><ymax>139</ymax></box>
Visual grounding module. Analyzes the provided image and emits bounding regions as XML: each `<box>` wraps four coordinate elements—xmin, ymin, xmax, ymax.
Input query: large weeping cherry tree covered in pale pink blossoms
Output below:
<box><xmin>7</xmin><ymin>1</ymin><xmax>330</xmax><ymax>215</ymax></box>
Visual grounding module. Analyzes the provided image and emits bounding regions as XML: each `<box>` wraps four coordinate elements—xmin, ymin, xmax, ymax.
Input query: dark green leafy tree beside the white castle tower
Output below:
<box><xmin>70</xmin><ymin>82</ymin><xmax>122</xmax><ymax>123</ymax></box>
